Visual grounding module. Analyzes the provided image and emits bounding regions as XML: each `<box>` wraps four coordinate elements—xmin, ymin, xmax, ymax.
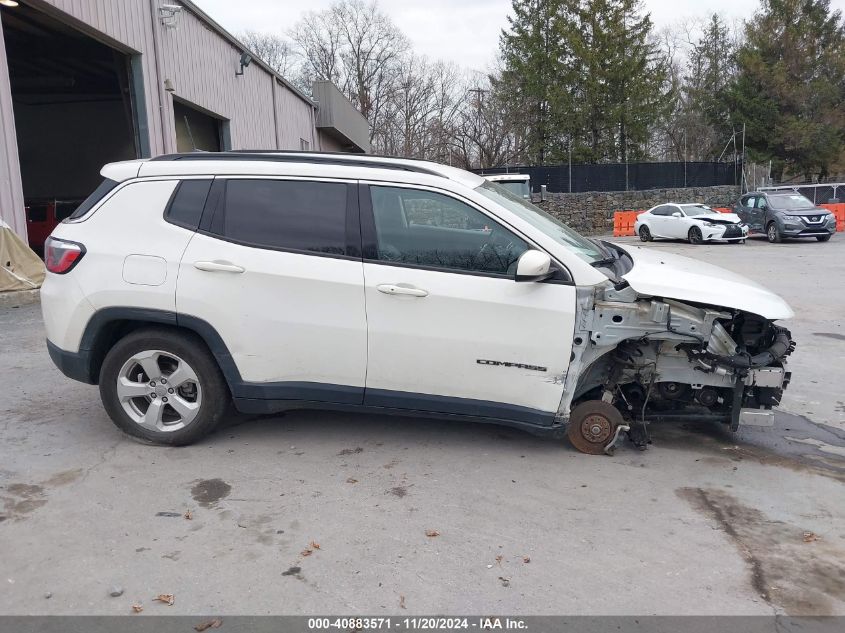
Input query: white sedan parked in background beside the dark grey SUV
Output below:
<box><xmin>634</xmin><ymin>204</ymin><xmax>748</xmax><ymax>244</ymax></box>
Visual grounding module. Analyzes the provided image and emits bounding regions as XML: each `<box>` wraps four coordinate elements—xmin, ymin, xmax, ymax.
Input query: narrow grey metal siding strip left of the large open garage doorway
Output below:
<box><xmin>0</xmin><ymin>13</ymin><xmax>26</xmax><ymax>239</ymax></box>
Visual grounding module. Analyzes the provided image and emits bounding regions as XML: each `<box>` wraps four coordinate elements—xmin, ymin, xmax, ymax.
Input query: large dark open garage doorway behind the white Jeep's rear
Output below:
<box><xmin>2</xmin><ymin>2</ymin><xmax>141</xmax><ymax>252</ymax></box>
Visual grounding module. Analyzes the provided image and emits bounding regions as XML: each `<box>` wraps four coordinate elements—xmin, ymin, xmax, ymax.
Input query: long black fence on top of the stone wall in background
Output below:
<box><xmin>473</xmin><ymin>163</ymin><xmax>742</xmax><ymax>193</ymax></box>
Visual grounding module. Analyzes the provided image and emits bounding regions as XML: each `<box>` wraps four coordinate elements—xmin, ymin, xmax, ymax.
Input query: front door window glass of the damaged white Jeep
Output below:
<box><xmin>370</xmin><ymin>187</ymin><xmax>529</xmax><ymax>275</ymax></box>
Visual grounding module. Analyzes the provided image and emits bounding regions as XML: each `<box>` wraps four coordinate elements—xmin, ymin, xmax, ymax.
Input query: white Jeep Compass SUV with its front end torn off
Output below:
<box><xmin>41</xmin><ymin>152</ymin><xmax>793</xmax><ymax>453</ymax></box>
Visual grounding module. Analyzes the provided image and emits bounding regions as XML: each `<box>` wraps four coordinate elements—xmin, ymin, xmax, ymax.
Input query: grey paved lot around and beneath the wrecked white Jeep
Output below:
<box><xmin>0</xmin><ymin>238</ymin><xmax>845</xmax><ymax>615</ymax></box>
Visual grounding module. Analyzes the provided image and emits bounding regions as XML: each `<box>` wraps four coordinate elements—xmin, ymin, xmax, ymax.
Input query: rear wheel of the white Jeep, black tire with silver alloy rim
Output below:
<box><xmin>100</xmin><ymin>328</ymin><xmax>231</xmax><ymax>446</ymax></box>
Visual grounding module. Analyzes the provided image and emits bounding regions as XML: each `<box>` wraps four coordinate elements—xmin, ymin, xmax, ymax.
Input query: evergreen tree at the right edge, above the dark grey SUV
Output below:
<box><xmin>730</xmin><ymin>0</ymin><xmax>845</xmax><ymax>180</ymax></box>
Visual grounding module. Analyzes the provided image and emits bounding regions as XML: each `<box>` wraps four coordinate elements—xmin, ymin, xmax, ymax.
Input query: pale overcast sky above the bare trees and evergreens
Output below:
<box><xmin>194</xmin><ymin>0</ymin><xmax>796</xmax><ymax>71</ymax></box>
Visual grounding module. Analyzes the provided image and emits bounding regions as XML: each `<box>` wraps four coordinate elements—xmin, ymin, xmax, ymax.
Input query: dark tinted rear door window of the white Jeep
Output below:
<box><xmin>222</xmin><ymin>180</ymin><xmax>347</xmax><ymax>255</ymax></box>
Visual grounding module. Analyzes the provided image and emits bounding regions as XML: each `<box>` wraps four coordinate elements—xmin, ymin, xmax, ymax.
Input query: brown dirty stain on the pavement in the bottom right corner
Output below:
<box><xmin>676</xmin><ymin>488</ymin><xmax>845</xmax><ymax>615</ymax></box>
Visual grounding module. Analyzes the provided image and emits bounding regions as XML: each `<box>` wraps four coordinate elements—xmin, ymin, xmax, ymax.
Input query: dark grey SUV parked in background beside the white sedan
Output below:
<box><xmin>734</xmin><ymin>191</ymin><xmax>836</xmax><ymax>243</ymax></box>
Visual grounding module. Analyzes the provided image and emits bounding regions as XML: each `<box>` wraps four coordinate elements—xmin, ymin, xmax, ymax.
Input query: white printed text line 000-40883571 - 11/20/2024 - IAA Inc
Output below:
<box><xmin>308</xmin><ymin>617</ymin><xmax>527</xmax><ymax>631</ymax></box>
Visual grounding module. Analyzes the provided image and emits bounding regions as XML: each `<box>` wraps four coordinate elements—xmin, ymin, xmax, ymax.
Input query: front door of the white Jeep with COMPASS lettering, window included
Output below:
<box><xmin>361</xmin><ymin>185</ymin><xmax>575</xmax><ymax>424</ymax></box>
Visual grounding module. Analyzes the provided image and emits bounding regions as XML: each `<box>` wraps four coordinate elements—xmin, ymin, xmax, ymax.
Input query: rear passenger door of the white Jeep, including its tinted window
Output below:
<box><xmin>176</xmin><ymin>177</ymin><xmax>367</xmax><ymax>404</ymax></box>
